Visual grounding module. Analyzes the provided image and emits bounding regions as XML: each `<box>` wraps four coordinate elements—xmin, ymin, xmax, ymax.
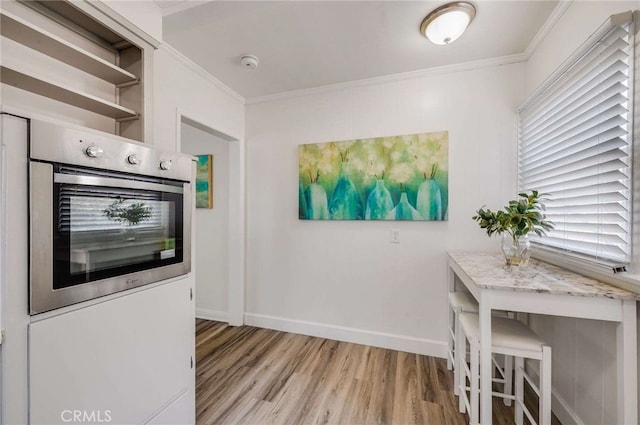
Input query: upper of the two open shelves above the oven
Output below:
<box><xmin>0</xmin><ymin>11</ymin><xmax>139</xmax><ymax>85</ymax></box>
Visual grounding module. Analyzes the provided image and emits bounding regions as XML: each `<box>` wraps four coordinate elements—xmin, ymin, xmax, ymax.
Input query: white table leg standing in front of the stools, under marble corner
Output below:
<box><xmin>479</xmin><ymin>291</ymin><xmax>493</xmax><ymax>425</ymax></box>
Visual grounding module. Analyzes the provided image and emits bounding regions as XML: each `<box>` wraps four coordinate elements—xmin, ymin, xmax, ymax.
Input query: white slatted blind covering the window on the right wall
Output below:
<box><xmin>518</xmin><ymin>14</ymin><xmax>633</xmax><ymax>263</ymax></box>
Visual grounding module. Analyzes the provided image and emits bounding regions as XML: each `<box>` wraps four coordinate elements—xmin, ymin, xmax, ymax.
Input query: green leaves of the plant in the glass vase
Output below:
<box><xmin>472</xmin><ymin>190</ymin><xmax>554</xmax><ymax>241</ymax></box>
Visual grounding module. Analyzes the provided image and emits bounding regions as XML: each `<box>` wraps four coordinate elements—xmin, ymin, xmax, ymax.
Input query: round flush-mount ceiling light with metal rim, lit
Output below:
<box><xmin>420</xmin><ymin>1</ymin><xmax>476</xmax><ymax>45</ymax></box>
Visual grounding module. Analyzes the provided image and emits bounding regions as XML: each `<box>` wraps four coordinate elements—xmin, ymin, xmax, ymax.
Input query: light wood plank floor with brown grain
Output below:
<box><xmin>196</xmin><ymin>320</ymin><xmax>558</xmax><ymax>425</ymax></box>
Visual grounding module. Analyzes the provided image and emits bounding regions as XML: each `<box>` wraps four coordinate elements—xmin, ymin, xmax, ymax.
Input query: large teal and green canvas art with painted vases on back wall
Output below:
<box><xmin>298</xmin><ymin>131</ymin><xmax>449</xmax><ymax>221</ymax></box>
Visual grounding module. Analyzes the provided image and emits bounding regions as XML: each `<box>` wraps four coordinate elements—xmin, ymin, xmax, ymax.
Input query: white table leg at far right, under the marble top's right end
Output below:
<box><xmin>616</xmin><ymin>300</ymin><xmax>638</xmax><ymax>425</ymax></box>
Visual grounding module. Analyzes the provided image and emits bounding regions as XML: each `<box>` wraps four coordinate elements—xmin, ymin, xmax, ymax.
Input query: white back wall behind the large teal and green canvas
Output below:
<box><xmin>245</xmin><ymin>64</ymin><xmax>524</xmax><ymax>357</ymax></box>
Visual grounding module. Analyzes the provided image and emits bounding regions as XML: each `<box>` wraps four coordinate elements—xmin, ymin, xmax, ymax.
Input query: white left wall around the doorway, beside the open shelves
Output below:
<box><xmin>153</xmin><ymin>45</ymin><xmax>245</xmax><ymax>325</ymax></box>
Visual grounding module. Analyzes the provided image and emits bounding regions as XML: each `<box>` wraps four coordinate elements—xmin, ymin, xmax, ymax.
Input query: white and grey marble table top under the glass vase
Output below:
<box><xmin>449</xmin><ymin>251</ymin><xmax>640</xmax><ymax>300</ymax></box>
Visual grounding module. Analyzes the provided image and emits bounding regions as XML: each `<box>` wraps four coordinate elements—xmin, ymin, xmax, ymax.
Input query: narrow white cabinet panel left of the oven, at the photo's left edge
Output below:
<box><xmin>0</xmin><ymin>114</ymin><xmax>29</xmax><ymax>424</ymax></box>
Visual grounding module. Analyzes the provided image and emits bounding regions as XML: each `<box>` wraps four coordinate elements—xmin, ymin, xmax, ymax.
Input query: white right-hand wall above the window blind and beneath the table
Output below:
<box><xmin>526</xmin><ymin>0</ymin><xmax>640</xmax><ymax>424</ymax></box>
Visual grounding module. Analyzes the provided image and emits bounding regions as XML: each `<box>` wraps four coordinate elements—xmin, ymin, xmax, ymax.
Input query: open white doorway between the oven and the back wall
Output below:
<box><xmin>177</xmin><ymin>114</ymin><xmax>244</xmax><ymax>326</ymax></box>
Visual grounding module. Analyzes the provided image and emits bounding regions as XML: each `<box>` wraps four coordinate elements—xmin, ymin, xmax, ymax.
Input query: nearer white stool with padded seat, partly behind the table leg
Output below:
<box><xmin>456</xmin><ymin>313</ymin><xmax>551</xmax><ymax>425</ymax></box>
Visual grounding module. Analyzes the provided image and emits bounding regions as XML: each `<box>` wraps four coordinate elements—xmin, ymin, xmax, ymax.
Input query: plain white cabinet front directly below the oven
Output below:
<box><xmin>29</xmin><ymin>276</ymin><xmax>195</xmax><ymax>424</ymax></box>
